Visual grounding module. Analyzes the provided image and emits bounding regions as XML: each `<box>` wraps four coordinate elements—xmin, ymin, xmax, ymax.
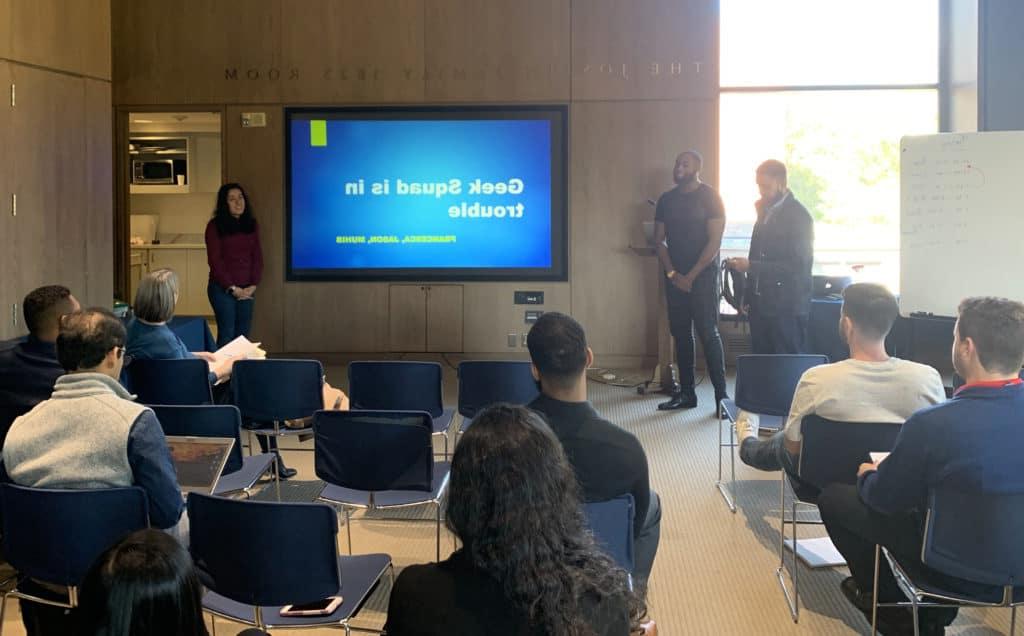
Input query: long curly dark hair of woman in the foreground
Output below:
<box><xmin>445</xmin><ymin>405</ymin><xmax>645</xmax><ymax>636</ymax></box>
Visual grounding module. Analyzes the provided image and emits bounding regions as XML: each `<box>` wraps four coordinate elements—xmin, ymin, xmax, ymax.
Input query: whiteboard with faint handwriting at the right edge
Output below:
<box><xmin>900</xmin><ymin>131</ymin><xmax>1024</xmax><ymax>315</ymax></box>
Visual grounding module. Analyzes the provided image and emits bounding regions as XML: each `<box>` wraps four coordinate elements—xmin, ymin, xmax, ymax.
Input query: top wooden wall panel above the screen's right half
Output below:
<box><xmin>424</xmin><ymin>0</ymin><xmax>570</xmax><ymax>101</ymax></box>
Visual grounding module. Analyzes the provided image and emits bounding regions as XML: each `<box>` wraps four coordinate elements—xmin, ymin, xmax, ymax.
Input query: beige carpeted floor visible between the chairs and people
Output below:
<box><xmin>4</xmin><ymin>364</ymin><xmax>1010</xmax><ymax>636</ymax></box>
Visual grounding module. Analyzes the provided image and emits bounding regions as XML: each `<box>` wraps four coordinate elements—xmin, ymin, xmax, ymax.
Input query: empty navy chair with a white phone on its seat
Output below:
<box><xmin>188</xmin><ymin>493</ymin><xmax>393</xmax><ymax>634</ymax></box>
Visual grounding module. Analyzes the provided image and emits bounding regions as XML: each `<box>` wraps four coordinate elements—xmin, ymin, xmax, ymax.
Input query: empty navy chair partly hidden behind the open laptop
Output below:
<box><xmin>152</xmin><ymin>405</ymin><xmax>278</xmax><ymax>498</ymax></box>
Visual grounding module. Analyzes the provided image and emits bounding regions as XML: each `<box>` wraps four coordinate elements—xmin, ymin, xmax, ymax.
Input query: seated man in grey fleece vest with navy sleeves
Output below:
<box><xmin>0</xmin><ymin>309</ymin><xmax>184</xmax><ymax>634</ymax></box>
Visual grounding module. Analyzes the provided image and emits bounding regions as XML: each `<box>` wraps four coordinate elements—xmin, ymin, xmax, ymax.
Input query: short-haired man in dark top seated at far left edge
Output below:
<box><xmin>0</xmin><ymin>285</ymin><xmax>81</xmax><ymax>447</ymax></box>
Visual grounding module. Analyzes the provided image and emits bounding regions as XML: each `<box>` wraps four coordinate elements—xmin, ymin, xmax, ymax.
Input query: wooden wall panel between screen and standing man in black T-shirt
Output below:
<box><xmin>570</xmin><ymin>100</ymin><xmax>718</xmax><ymax>355</ymax></box>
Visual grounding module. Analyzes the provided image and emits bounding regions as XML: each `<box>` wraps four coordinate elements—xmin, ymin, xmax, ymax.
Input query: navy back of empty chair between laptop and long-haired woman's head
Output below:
<box><xmin>313</xmin><ymin>411</ymin><xmax>434</xmax><ymax>492</ymax></box>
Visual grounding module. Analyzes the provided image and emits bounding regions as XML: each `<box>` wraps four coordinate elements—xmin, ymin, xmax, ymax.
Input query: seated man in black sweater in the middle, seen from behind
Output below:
<box><xmin>526</xmin><ymin>311</ymin><xmax>662</xmax><ymax>592</ymax></box>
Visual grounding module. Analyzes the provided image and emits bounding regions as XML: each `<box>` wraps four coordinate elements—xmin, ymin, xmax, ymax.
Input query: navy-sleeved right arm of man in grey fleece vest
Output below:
<box><xmin>128</xmin><ymin>409</ymin><xmax>184</xmax><ymax>529</ymax></box>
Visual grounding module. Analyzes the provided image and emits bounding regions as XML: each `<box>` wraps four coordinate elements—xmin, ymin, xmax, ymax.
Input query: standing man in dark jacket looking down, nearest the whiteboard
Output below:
<box><xmin>729</xmin><ymin>159</ymin><xmax>814</xmax><ymax>353</ymax></box>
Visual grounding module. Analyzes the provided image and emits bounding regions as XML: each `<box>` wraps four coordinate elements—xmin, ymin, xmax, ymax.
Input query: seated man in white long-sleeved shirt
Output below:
<box><xmin>736</xmin><ymin>283</ymin><xmax>945</xmax><ymax>474</ymax></box>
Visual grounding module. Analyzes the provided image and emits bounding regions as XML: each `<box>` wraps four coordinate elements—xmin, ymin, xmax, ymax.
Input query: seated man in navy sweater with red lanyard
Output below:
<box><xmin>818</xmin><ymin>297</ymin><xmax>1024</xmax><ymax>636</ymax></box>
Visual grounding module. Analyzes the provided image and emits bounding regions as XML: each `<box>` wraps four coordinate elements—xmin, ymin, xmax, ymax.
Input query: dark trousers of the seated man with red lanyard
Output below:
<box><xmin>818</xmin><ymin>483</ymin><xmax>966</xmax><ymax>625</ymax></box>
